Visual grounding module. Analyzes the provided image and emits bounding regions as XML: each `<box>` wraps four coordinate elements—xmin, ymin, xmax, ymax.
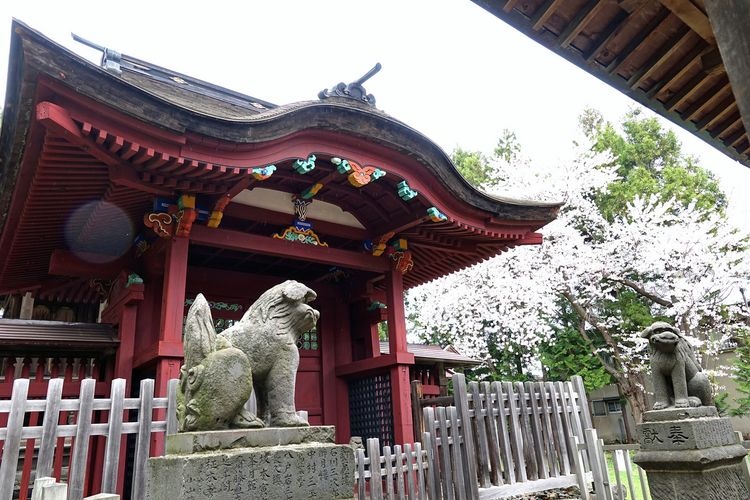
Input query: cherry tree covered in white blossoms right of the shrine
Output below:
<box><xmin>407</xmin><ymin>109</ymin><xmax>750</xmax><ymax>430</ymax></box>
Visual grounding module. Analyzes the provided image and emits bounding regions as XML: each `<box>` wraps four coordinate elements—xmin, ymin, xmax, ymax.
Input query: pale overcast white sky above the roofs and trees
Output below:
<box><xmin>0</xmin><ymin>0</ymin><xmax>750</xmax><ymax>231</ymax></box>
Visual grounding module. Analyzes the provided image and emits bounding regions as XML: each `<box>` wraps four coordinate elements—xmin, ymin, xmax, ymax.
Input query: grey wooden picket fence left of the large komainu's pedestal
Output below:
<box><xmin>0</xmin><ymin>378</ymin><xmax>178</xmax><ymax>500</ymax></box>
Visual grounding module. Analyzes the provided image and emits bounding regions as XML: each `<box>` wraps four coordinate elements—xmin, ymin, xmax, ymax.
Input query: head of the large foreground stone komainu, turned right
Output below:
<box><xmin>253</xmin><ymin>280</ymin><xmax>320</xmax><ymax>337</ymax></box>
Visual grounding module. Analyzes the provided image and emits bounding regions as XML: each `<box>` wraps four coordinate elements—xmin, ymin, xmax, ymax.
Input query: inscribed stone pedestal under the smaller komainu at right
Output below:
<box><xmin>634</xmin><ymin>406</ymin><xmax>750</xmax><ymax>500</ymax></box>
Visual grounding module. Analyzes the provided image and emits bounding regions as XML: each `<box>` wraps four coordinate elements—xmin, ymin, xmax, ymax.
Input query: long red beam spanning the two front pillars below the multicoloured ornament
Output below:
<box><xmin>190</xmin><ymin>225</ymin><xmax>390</xmax><ymax>273</ymax></box>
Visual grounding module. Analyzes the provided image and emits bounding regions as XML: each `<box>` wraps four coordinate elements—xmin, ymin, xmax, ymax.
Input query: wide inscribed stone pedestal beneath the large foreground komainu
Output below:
<box><xmin>146</xmin><ymin>427</ymin><xmax>354</xmax><ymax>500</ymax></box>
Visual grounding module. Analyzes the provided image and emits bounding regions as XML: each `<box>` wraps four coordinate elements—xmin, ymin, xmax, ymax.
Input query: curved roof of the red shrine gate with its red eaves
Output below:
<box><xmin>0</xmin><ymin>22</ymin><xmax>560</xmax><ymax>300</ymax></box>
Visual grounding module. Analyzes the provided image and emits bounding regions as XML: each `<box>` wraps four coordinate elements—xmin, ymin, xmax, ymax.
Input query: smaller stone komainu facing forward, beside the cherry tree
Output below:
<box><xmin>641</xmin><ymin>321</ymin><xmax>711</xmax><ymax>410</ymax></box>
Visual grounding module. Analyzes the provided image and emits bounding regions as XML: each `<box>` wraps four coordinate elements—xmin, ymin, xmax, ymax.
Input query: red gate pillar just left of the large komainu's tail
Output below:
<box><xmin>151</xmin><ymin>237</ymin><xmax>190</xmax><ymax>456</ymax></box>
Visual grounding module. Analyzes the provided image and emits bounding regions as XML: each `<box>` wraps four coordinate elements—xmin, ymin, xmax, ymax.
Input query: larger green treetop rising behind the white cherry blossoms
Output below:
<box><xmin>579</xmin><ymin>109</ymin><xmax>727</xmax><ymax>222</ymax></box>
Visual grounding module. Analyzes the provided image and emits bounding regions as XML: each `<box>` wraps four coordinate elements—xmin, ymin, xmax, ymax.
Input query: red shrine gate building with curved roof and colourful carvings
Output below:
<box><xmin>0</xmin><ymin>21</ymin><xmax>560</xmax><ymax>453</ymax></box>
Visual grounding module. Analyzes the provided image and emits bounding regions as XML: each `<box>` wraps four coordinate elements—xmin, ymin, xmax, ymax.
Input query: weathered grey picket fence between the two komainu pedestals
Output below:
<box><xmin>355</xmin><ymin>374</ymin><xmax>611</xmax><ymax>500</ymax></box>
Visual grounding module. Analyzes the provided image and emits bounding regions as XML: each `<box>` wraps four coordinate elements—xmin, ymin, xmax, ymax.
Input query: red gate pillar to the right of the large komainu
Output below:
<box><xmin>385</xmin><ymin>269</ymin><xmax>414</xmax><ymax>444</ymax></box>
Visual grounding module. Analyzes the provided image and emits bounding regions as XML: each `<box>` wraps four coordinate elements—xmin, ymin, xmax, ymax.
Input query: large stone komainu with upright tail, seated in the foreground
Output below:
<box><xmin>178</xmin><ymin>281</ymin><xmax>319</xmax><ymax>432</ymax></box>
